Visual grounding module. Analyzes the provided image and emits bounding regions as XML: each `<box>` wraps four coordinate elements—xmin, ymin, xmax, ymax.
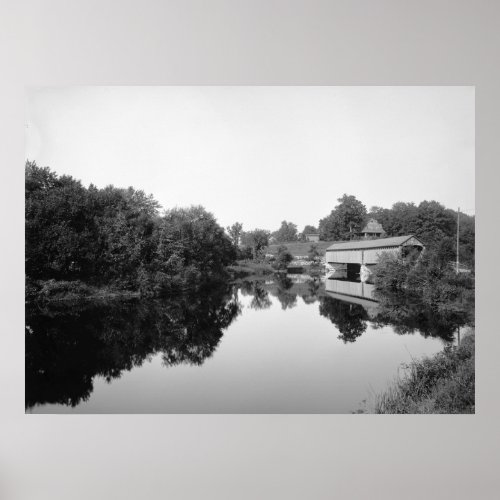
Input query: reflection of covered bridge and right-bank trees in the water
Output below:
<box><xmin>240</xmin><ymin>275</ymin><xmax>474</xmax><ymax>343</ymax></box>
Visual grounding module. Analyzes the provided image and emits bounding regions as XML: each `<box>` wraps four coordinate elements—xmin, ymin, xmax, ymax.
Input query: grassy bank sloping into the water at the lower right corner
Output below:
<box><xmin>375</xmin><ymin>333</ymin><xmax>475</xmax><ymax>413</ymax></box>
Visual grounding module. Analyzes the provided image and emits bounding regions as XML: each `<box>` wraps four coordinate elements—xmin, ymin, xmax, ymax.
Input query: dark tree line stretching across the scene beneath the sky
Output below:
<box><xmin>25</xmin><ymin>161</ymin><xmax>475</xmax><ymax>295</ymax></box>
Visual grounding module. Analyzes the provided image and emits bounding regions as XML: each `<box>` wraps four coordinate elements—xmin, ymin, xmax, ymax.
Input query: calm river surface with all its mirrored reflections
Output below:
<box><xmin>26</xmin><ymin>276</ymin><xmax>464</xmax><ymax>413</ymax></box>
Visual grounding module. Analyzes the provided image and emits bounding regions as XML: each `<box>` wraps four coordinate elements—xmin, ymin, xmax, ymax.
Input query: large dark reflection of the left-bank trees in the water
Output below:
<box><xmin>25</xmin><ymin>286</ymin><xmax>241</xmax><ymax>408</ymax></box>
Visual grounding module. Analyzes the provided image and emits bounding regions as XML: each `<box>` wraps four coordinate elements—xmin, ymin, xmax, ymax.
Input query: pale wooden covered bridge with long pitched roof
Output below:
<box><xmin>325</xmin><ymin>234</ymin><xmax>425</xmax><ymax>266</ymax></box>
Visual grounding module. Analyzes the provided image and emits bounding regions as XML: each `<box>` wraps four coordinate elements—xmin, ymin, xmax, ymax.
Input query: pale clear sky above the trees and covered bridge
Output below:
<box><xmin>26</xmin><ymin>86</ymin><xmax>475</xmax><ymax>231</ymax></box>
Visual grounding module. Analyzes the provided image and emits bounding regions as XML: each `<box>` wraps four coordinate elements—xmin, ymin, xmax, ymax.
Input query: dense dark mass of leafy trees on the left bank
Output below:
<box><xmin>25</xmin><ymin>162</ymin><xmax>236</xmax><ymax>294</ymax></box>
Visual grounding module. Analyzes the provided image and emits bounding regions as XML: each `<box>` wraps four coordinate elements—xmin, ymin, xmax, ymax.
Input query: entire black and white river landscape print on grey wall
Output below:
<box><xmin>25</xmin><ymin>86</ymin><xmax>475</xmax><ymax>414</ymax></box>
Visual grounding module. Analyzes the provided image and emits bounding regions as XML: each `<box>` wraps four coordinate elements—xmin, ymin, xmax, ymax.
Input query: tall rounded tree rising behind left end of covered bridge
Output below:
<box><xmin>319</xmin><ymin>194</ymin><xmax>366</xmax><ymax>240</ymax></box>
